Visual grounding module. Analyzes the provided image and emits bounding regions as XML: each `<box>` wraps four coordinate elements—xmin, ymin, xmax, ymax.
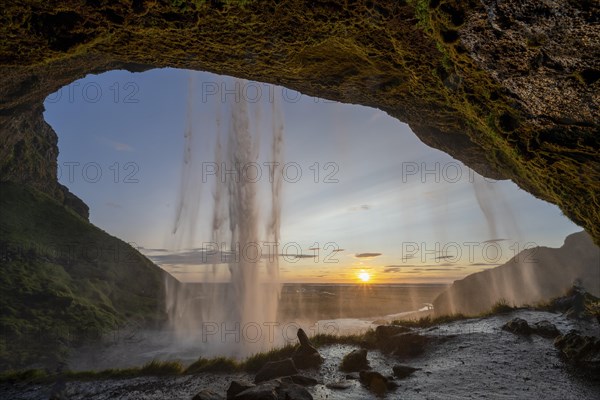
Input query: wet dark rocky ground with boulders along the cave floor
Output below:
<box><xmin>0</xmin><ymin>310</ymin><xmax>600</xmax><ymax>400</ymax></box>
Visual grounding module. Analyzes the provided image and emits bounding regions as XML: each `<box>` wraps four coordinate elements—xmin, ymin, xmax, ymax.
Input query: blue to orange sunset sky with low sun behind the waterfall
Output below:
<box><xmin>45</xmin><ymin>69</ymin><xmax>581</xmax><ymax>283</ymax></box>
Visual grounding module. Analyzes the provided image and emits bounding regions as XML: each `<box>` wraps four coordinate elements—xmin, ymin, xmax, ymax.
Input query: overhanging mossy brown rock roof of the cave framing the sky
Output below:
<box><xmin>0</xmin><ymin>0</ymin><xmax>600</xmax><ymax>242</ymax></box>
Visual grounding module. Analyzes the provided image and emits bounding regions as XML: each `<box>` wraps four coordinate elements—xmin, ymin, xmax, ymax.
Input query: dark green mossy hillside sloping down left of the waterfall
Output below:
<box><xmin>0</xmin><ymin>182</ymin><xmax>164</xmax><ymax>370</ymax></box>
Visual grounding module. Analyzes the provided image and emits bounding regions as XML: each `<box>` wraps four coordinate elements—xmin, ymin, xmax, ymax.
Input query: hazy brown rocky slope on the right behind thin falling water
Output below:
<box><xmin>433</xmin><ymin>232</ymin><xmax>600</xmax><ymax>315</ymax></box>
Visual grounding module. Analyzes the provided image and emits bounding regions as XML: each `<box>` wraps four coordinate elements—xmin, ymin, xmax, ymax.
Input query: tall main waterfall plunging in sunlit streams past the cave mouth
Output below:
<box><xmin>166</xmin><ymin>80</ymin><xmax>284</xmax><ymax>357</ymax></box>
